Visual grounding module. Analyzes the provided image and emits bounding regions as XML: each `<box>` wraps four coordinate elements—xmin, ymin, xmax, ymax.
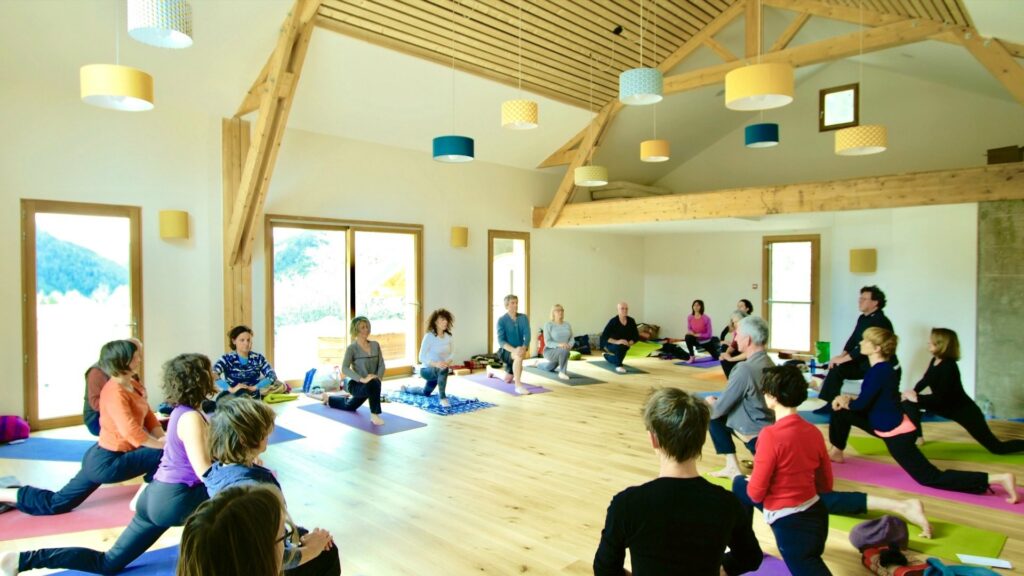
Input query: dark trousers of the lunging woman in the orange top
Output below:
<box><xmin>17</xmin><ymin>444</ymin><xmax>164</xmax><ymax>516</ymax></box>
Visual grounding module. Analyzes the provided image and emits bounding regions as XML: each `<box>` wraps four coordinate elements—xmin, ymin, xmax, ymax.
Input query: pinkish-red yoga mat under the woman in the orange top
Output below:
<box><xmin>0</xmin><ymin>484</ymin><xmax>138</xmax><ymax>540</ymax></box>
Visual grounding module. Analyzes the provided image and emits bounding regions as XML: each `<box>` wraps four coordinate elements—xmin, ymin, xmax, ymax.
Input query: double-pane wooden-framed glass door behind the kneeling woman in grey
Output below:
<box><xmin>265</xmin><ymin>215</ymin><xmax>423</xmax><ymax>380</ymax></box>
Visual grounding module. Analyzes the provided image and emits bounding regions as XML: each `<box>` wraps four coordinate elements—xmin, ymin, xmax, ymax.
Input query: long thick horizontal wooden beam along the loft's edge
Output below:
<box><xmin>534</xmin><ymin>163</ymin><xmax>1024</xmax><ymax>228</ymax></box>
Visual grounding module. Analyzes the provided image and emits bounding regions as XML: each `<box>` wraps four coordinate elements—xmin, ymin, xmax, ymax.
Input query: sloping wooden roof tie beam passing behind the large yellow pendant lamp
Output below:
<box><xmin>665</xmin><ymin>19</ymin><xmax>946</xmax><ymax>95</ymax></box>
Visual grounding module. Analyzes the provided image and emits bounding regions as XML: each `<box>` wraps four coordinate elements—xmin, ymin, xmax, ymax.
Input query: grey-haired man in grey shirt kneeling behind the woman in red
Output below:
<box><xmin>708</xmin><ymin>316</ymin><xmax>775</xmax><ymax>478</ymax></box>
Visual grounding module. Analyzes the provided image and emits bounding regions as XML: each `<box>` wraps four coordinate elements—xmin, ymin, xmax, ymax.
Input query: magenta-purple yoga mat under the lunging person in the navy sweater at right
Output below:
<box><xmin>833</xmin><ymin>456</ymin><xmax>1024</xmax><ymax>515</ymax></box>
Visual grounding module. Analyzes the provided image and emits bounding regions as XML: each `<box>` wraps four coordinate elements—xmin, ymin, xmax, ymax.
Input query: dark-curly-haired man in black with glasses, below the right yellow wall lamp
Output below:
<box><xmin>814</xmin><ymin>286</ymin><xmax>899</xmax><ymax>414</ymax></box>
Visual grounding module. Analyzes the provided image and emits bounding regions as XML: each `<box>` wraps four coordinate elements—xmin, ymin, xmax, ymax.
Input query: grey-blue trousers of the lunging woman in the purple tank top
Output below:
<box><xmin>18</xmin><ymin>481</ymin><xmax>209</xmax><ymax>574</ymax></box>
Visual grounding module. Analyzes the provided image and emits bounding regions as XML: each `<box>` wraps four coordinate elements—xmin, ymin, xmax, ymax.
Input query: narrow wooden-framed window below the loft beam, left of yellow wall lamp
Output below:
<box><xmin>761</xmin><ymin>235</ymin><xmax>820</xmax><ymax>353</ymax></box>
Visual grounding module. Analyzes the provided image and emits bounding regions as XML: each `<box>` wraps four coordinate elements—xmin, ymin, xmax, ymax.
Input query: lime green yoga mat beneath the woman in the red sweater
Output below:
<box><xmin>705</xmin><ymin>471</ymin><xmax>1007</xmax><ymax>560</ymax></box>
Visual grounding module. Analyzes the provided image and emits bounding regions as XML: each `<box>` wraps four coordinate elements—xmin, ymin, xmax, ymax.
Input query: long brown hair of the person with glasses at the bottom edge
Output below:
<box><xmin>176</xmin><ymin>485</ymin><xmax>287</xmax><ymax>576</ymax></box>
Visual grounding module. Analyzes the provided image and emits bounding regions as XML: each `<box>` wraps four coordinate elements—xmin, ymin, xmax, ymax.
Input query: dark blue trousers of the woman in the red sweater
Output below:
<box><xmin>732</xmin><ymin>476</ymin><xmax>831</xmax><ymax>576</ymax></box>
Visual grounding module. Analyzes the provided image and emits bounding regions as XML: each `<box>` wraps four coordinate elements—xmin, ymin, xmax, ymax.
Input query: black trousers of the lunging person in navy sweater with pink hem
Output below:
<box><xmin>828</xmin><ymin>410</ymin><xmax>988</xmax><ymax>494</ymax></box>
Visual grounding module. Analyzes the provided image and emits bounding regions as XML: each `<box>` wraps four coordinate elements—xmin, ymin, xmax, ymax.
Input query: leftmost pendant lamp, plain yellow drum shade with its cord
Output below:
<box><xmin>79</xmin><ymin>1</ymin><xmax>153</xmax><ymax>112</ymax></box>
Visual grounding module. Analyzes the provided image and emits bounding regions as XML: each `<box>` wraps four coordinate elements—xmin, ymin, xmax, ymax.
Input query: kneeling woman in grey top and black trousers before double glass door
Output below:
<box><xmin>324</xmin><ymin>316</ymin><xmax>384</xmax><ymax>426</ymax></box>
